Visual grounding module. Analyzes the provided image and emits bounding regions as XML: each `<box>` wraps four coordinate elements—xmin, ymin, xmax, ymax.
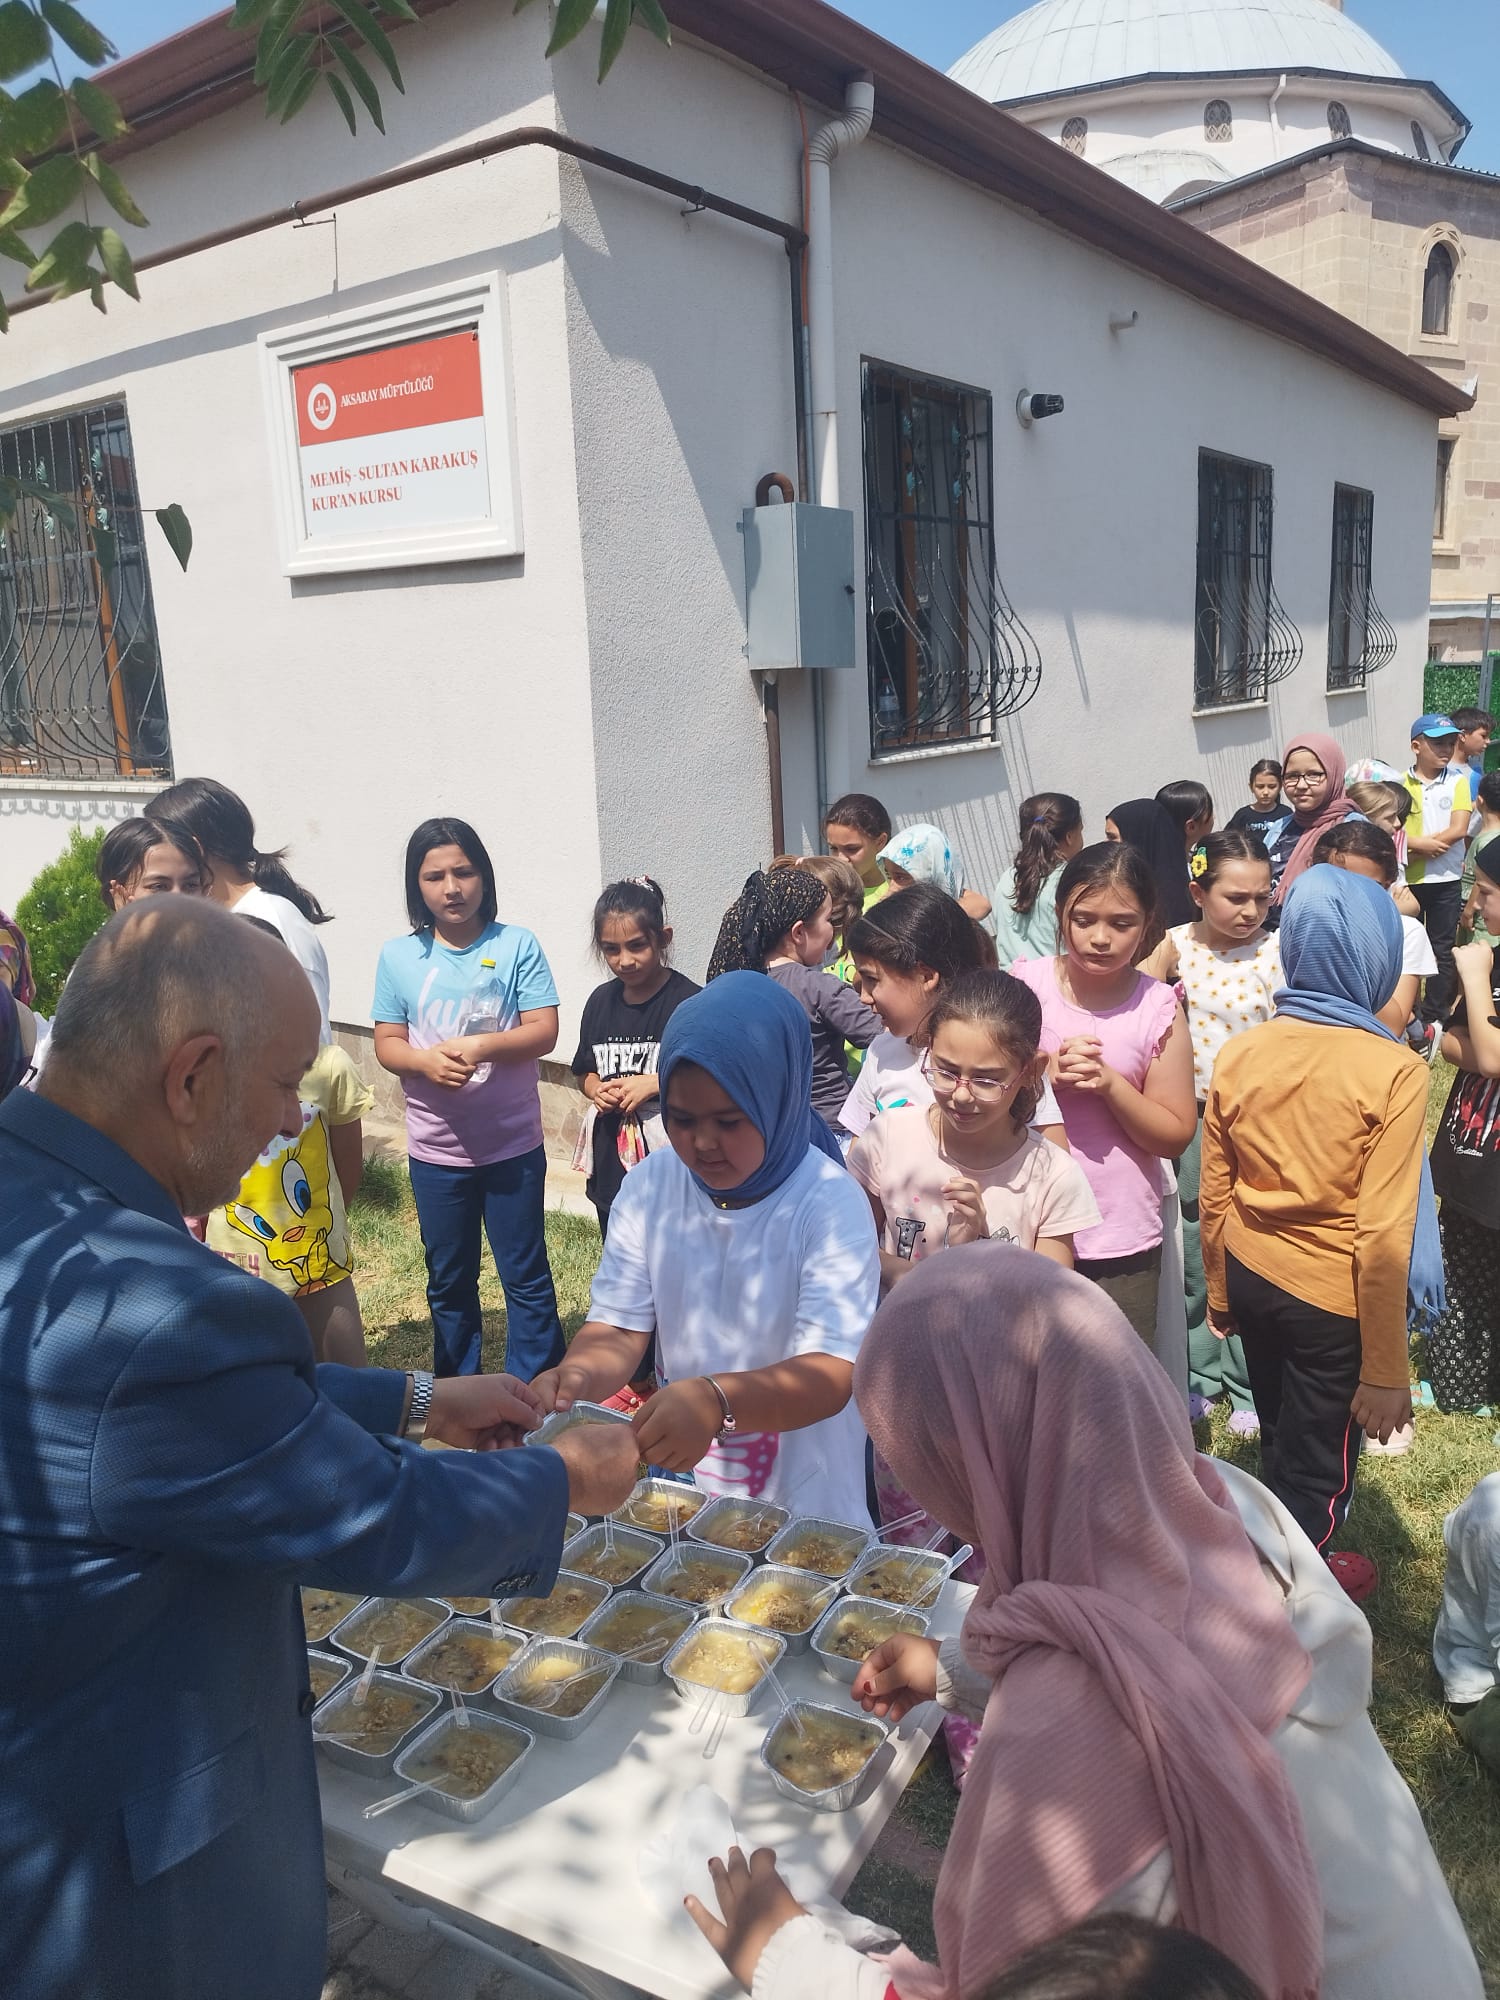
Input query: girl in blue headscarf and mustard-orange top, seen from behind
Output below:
<box><xmin>1200</xmin><ymin>868</ymin><xmax>1442</xmax><ymax>1598</ymax></box>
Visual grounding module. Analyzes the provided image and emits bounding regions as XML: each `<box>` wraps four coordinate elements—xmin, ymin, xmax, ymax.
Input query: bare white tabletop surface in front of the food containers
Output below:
<box><xmin>318</xmin><ymin>1584</ymin><xmax>974</xmax><ymax>2000</ymax></box>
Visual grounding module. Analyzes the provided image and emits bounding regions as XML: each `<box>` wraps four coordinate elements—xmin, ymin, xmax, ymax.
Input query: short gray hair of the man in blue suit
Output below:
<box><xmin>46</xmin><ymin>896</ymin><xmax>284</xmax><ymax>1098</ymax></box>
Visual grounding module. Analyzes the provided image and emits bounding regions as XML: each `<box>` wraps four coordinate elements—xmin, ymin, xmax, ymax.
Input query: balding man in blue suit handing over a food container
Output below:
<box><xmin>0</xmin><ymin>896</ymin><xmax>636</xmax><ymax>2000</ymax></box>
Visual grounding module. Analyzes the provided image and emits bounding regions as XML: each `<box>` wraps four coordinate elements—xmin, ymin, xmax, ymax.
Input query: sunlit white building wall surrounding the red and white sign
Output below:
<box><xmin>0</xmin><ymin>8</ymin><xmax>612</xmax><ymax>1022</ymax></box>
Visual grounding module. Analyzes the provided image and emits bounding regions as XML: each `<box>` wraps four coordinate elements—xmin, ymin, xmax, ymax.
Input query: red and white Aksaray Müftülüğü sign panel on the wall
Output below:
<box><xmin>290</xmin><ymin>326</ymin><xmax>490</xmax><ymax>544</ymax></box>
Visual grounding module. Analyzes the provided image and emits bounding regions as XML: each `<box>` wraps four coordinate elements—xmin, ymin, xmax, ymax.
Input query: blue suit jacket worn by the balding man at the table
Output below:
<box><xmin>0</xmin><ymin>1090</ymin><xmax>568</xmax><ymax>2000</ymax></box>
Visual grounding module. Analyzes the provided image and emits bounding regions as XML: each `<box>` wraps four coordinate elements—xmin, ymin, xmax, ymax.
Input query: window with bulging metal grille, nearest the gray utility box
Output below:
<box><xmin>864</xmin><ymin>362</ymin><xmax>1042</xmax><ymax>756</ymax></box>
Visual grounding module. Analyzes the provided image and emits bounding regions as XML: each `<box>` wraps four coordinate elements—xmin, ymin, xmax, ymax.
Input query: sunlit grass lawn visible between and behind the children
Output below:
<box><xmin>352</xmin><ymin>1136</ymin><xmax>1500</xmax><ymax>2000</ymax></box>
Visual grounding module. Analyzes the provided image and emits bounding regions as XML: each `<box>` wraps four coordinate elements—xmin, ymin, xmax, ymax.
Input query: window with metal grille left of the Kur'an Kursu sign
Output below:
<box><xmin>0</xmin><ymin>402</ymin><xmax>172</xmax><ymax>778</ymax></box>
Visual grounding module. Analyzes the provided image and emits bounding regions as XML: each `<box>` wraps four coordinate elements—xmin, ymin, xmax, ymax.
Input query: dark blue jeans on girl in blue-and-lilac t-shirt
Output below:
<box><xmin>410</xmin><ymin>1146</ymin><xmax>562</xmax><ymax>1382</ymax></box>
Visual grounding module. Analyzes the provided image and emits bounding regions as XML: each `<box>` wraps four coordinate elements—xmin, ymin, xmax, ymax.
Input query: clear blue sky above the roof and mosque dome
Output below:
<box><xmin>50</xmin><ymin>0</ymin><xmax>1500</xmax><ymax>172</ymax></box>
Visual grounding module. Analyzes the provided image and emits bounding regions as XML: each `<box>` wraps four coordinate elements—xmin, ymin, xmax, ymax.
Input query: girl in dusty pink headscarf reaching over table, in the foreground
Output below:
<box><xmin>690</xmin><ymin>1246</ymin><xmax>1480</xmax><ymax>2000</ymax></box>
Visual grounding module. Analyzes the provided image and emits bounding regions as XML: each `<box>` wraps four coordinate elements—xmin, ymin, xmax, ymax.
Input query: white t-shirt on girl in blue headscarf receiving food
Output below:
<box><xmin>590</xmin><ymin>1148</ymin><xmax>880</xmax><ymax>1524</ymax></box>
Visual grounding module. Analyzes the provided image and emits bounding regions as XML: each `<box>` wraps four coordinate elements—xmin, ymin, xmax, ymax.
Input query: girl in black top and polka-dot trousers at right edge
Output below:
<box><xmin>1428</xmin><ymin>840</ymin><xmax>1500</xmax><ymax>1410</ymax></box>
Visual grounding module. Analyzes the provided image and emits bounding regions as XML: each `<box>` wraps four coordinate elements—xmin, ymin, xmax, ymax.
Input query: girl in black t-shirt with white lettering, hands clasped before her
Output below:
<box><xmin>572</xmin><ymin>876</ymin><xmax>698</xmax><ymax>1232</ymax></box>
